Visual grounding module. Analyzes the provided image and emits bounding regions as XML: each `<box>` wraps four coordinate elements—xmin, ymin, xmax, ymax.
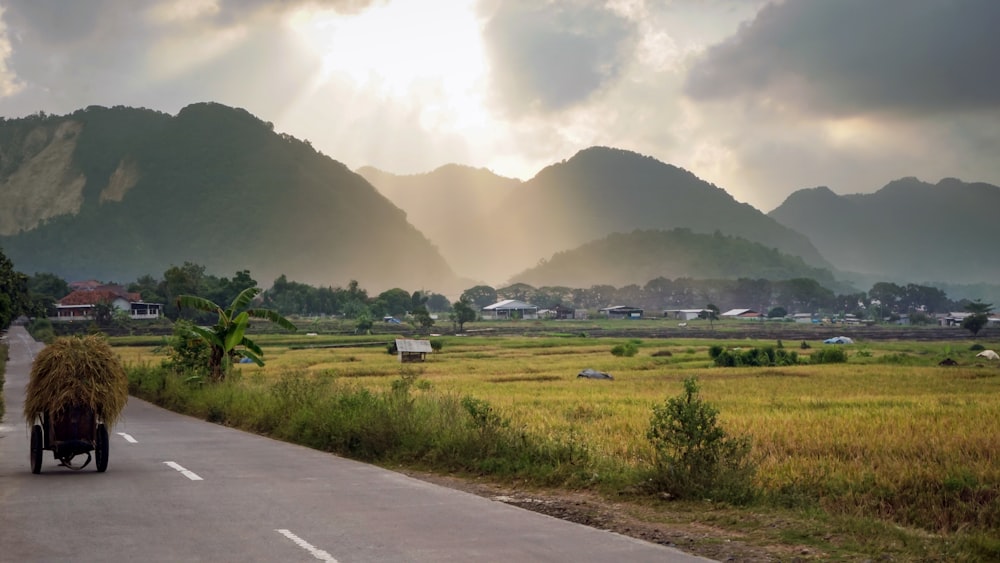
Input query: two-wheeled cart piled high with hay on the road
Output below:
<box><xmin>24</xmin><ymin>336</ymin><xmax>128</xmax><ymax>473</ymax></box>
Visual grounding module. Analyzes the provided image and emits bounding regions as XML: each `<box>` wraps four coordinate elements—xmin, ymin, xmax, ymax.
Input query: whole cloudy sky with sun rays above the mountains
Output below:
<box><xmin>0</xmin><ymin>0</ymin><xmax>1000</xmax><ymax>212</ymax></box>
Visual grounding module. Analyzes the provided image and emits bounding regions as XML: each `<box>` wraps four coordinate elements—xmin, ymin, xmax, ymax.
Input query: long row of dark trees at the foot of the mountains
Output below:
<box><xmin>0</xmin><ymin>253</ymin><xmax>992</xmax><ymax>330</ymax></box>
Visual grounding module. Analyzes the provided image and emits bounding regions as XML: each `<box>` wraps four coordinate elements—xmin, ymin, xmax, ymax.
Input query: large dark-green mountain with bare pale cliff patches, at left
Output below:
<box><xmin>0</xmin><ymin>103</ymin><xmax>461</xmax><ymax>291</ymax></box>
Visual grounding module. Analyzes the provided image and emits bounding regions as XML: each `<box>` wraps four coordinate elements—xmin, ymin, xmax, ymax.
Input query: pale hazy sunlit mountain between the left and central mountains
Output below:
<box><xmin>357</xmin><ymin>164</ymin><xmax>521</xmax><ymax>280</ymax></box>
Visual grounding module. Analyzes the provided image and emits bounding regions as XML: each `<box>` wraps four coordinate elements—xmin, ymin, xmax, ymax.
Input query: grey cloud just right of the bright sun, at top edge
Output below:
<box><xmin>483</xmin><ymin>1</ymin><xmax>635</xmax><ymax>114</ymax></box>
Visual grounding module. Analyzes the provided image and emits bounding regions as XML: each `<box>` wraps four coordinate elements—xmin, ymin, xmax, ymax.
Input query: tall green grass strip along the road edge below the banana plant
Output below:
<box><xmin>129</xmin><ymin>366</ymin><xmax>593</xmax><ymax>486</ymax></box>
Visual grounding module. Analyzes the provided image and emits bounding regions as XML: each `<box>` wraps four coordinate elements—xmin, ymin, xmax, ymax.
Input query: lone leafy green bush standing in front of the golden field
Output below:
<box><xmin>646</xmin><ymin>377</ymin><xmax>756</xmax><ymax>504</ymax></box>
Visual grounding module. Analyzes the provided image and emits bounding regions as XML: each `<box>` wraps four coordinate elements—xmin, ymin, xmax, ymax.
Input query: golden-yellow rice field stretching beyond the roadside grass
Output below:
<box><xmin>117</xmin><ymin>333</ymin><xmax>1000</xmax><ymax>560</ymax></box>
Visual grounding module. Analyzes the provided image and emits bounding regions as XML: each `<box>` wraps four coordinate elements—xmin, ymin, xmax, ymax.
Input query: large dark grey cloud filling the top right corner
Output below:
<box><xmin>685</xmin><ymin>0</ymin><xmax>1000</xmax><ymax>116</ymax></box>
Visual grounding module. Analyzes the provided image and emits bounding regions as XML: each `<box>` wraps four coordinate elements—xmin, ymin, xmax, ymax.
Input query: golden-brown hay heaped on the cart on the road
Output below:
<box><xmin>24</xmin><ymin>335</ymin><xmax>128</xmax><ymax>427</ymax></box>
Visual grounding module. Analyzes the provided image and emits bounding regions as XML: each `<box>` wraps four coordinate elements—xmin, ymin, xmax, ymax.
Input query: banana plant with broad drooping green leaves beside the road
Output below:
<box><xmin>177</xmin><ymin>287</ymin><xmax>296</xmax><ymax>381</ymax></box>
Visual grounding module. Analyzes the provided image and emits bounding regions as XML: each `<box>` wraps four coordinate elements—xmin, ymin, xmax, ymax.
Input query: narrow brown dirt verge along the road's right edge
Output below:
<box><xmin>401</xmin><ymin>471</ymin><xmax>812</xmax><ymax>563</ymax></box>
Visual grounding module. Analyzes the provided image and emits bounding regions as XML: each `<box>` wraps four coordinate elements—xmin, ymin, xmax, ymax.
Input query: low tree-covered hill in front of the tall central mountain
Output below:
<box><xmin>513</xmin><ymin>229</ymin><xmax>839</xmax><ymax>287</ymax></box>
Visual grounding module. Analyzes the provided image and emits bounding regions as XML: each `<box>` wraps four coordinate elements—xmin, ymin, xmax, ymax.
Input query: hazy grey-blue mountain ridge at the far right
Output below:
<box><xmin>769</xmin><ymin>178</ymin><xmax>1000</xmax><ymax>283</ymax></box>
